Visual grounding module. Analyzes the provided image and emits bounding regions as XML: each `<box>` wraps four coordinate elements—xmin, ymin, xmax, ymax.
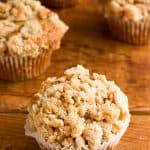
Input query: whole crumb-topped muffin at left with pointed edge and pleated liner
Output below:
<box><xmin>0</xmin><ymin>0</ymin><xmax>68</xmax><ymax>80</ymax></box>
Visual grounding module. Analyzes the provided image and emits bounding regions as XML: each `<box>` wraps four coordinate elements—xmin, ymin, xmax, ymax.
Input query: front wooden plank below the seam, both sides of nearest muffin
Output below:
<box><xmin>0</xmin><ymin>113</ymin><xmax>150</xmax><ymax>150</ymax></box>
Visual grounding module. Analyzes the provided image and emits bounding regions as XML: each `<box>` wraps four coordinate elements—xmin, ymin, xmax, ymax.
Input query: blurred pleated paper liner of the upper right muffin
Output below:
<box><xmin>106</xmin><ymin>17</ymin><xmax>150</xmax><ymax>45</ymax></box>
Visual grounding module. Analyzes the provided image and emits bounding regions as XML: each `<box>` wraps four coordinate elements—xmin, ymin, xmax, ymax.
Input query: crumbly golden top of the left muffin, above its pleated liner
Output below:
<box><xmin>0</xmin><ymin>0</ymin><xmax>68</xmax><ymax>57</ymax></box>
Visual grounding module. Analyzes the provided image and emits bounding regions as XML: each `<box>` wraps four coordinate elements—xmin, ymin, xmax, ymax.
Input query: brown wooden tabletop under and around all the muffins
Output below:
<box><xmin>0</xmin><ymin>0</ymin><xmax>150</xmax><ymax>150</ymax></box>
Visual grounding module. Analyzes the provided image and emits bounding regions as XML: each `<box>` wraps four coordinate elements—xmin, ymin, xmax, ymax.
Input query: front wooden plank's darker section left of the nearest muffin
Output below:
<box><xmin>0</xmin><ymin>113</ymin><xmax>38</xmax><ymax>150</ymax></box>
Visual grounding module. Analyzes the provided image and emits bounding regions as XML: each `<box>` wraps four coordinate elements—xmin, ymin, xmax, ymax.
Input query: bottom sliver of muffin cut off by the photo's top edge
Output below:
<box><xmin>41</xmin><ymin>0</ymin><xmax>78</xmax><ymax>8</ymax></box>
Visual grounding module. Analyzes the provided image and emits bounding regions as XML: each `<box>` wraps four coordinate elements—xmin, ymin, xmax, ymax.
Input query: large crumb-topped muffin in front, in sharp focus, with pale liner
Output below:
<box><xmin>25</xmin><ymin>65</ymin><xmax>130</xmax><ymax>150</ymax></box>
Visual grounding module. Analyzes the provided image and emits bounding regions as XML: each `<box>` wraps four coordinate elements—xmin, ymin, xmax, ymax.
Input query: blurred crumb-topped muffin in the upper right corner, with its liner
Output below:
<box><xmin>100</xmin><ymin>0</ymin><xmax>150</xmax><ymax>45</ymax></box>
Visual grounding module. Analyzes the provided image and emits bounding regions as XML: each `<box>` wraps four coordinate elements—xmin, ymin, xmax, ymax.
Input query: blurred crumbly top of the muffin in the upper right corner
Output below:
<box><xmin>100</xmin><ymin>0</ymin><xmax>150</xmax><ymax>21</ymax></box>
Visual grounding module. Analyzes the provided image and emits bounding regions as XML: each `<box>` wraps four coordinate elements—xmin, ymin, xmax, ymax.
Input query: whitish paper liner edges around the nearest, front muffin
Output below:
<box><xmin>24</xmin><ymin>116</ymin><xmax>130</xmax><ymax>150</ymax></box>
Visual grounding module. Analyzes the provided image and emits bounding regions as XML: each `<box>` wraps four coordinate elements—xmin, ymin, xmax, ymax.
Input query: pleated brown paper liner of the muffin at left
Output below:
<box><xmin>0</xmin><ymin>50</ymin><xmax>52</xmax><ymax>81</ymax></box>
